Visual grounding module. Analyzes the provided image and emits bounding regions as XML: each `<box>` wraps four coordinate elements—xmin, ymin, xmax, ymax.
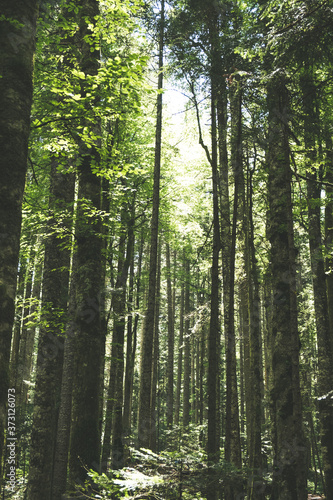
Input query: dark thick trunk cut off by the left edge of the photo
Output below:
<box><xmin>0</xmin><ymin>0</ymin><xmax>38</xmax><ymax>492</ymax></box>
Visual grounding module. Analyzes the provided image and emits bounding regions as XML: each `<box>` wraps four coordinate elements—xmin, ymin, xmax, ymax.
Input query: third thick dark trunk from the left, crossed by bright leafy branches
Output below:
<box><xmin>69</xmin><ymin>0</ymin><xmax>104</xmax><ymax>485</ymax></box>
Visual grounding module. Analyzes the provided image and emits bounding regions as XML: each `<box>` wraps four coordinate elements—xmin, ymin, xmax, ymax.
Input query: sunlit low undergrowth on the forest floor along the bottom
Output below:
<box><xmin>3</xmin><ymin>449</ymin><xmax>325</xmax><ymax>500</ymax></box>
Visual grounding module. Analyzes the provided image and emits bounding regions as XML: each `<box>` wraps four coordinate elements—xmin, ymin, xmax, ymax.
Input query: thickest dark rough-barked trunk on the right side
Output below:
<box><xmin>267</xmin><ymin>70</ymin><xmax>306</xmax><ymax>500</ymax></box>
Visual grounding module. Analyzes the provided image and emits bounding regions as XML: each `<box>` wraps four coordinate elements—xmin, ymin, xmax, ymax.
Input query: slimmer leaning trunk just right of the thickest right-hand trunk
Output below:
<box><xmin>301</xmin><ymin>68</ymin><xmax>333</xmax><ymax>500</ymax></box>
